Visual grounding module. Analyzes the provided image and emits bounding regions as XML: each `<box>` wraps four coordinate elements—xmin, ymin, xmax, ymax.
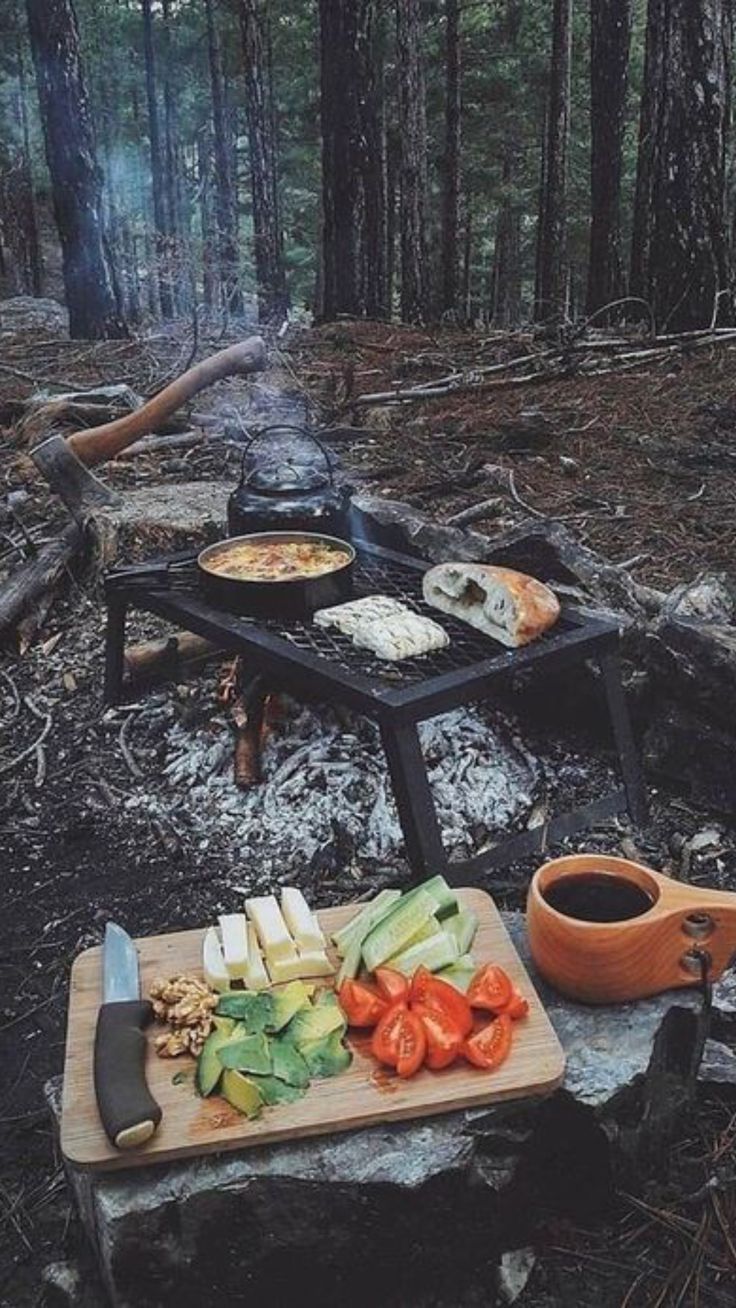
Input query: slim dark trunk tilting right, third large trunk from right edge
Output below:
<box><xmin>535</xmin><ymin>0</ymin><xmax>573</xmax><ymax>323</ymax></box>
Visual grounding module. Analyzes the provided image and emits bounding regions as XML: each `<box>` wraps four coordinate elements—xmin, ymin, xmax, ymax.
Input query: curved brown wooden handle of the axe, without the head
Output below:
<box><xmin>67</xmin><ymin>336</ymin><xmax>267</xmax><ymax>468</ymax></box>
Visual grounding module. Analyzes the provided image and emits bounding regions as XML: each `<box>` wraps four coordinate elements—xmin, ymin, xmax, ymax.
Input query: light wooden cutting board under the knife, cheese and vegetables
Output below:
<box><xmin>61</xmin><ymin>889</ymin><xmax>565</xmax><ymax>1171</ymax></box>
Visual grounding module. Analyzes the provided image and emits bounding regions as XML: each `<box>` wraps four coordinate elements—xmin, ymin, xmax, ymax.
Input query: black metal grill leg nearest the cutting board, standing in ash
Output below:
<box><xmin>380</xmin><ymin>722</ymin><xmax>447</xmax><ymax>880</ymax></box>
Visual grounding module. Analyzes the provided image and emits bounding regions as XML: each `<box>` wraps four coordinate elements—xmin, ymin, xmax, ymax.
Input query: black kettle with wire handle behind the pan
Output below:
<box><xmin>227</xmin><ymin>424</ymin><xmax>352</xmax><ymax>540</ymax></box>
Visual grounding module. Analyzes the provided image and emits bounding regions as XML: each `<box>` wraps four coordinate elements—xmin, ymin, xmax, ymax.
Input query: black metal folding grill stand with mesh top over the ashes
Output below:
<box><xmin>105</xmin><ymin>544</ymin><xmax>646</xmax><ymax>886</ymax></box>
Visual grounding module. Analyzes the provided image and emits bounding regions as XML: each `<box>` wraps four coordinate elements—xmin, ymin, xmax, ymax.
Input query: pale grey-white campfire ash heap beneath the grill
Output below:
<box><xmin>126</xmin><ymin>701</ymin><xmax>544</xmax><ymax>875</ymax></box>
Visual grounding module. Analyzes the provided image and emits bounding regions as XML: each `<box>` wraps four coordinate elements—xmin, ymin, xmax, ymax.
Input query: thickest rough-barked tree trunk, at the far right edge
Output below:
<box><xmin>635</xmin><ymin>0</ymin><xmax>733</xmax><ymax>331</ymax></box>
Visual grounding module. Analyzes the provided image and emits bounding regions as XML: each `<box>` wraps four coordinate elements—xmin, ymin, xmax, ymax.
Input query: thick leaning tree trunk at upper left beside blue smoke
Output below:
<box><xmin>26</xmin><ymin>0</ymin><xmax>127</xmax><ymax>339</ymax></box>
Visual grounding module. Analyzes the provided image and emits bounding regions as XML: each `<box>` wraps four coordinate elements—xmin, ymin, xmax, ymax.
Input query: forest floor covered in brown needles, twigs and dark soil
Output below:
<box><xmin>0</xmin><ymin>308</ymin><xmax>736</xmax><ymax>1308</ymax></box>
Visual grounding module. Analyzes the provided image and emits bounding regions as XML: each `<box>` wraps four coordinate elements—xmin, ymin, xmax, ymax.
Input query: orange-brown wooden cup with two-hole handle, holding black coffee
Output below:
<box><xmin>527</xmin><ymin>854</ymin><xmax>736</xmax><ymax>1003</ymax></box>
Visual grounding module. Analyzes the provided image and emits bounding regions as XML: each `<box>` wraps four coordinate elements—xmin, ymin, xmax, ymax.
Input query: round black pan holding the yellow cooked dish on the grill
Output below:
<box><xmin>197</xmin><ymin>531</ymin><xmax>356</xmax><ymax>617</ymax></box>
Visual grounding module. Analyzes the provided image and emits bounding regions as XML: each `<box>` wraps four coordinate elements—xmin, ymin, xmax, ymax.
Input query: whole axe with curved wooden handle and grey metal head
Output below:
<box><xmin>30</xmin><ymin>336</ymin><xmax>267</xmax><ymax>518</ymax></box>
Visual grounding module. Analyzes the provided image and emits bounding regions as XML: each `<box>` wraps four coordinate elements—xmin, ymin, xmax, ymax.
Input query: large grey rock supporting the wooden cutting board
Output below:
<box><xmin>48</xmin><ymin>913</ymin><xmax>721</xmax><ymax>1308</ymax></box>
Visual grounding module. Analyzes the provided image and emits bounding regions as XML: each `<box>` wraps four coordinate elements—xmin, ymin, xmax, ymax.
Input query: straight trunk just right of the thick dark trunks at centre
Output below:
<box><xmin>396</xmin><ymin>0</ymin><xmax>429</xmax><ymax>323</ymax></box>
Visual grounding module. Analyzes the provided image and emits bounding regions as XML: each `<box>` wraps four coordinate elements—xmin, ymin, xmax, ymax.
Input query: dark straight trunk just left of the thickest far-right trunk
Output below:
<box><xmin>587</xmin><ymin>0</ymin><xmax>633</xmax><ymax>314</ymax></box>
